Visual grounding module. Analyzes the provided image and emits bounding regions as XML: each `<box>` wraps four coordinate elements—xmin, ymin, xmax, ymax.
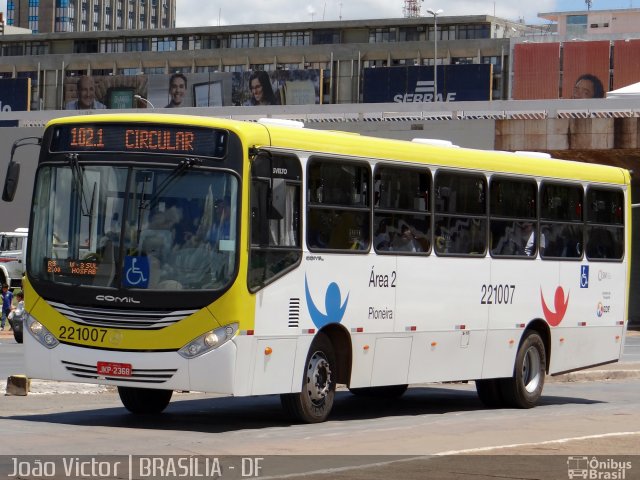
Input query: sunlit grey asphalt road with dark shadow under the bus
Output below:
<box><xmin>0</xmin><ymin>334</ymin><xmax>640</xmax><ymax>480</ymax></box>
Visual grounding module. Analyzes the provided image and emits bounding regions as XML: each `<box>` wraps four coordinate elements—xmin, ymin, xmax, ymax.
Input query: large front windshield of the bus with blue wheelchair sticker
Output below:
<box><xmin>28</xmin><ymin>160</ymin><xmax>238</xmax><ymax>290</ymax></box>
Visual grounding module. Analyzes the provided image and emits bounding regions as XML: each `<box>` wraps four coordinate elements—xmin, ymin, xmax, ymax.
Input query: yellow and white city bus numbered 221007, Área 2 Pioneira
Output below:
<box><xmin>3</xmin><ymin>114</ymin><xmax>631</xmax><ymax>422</ymax></box>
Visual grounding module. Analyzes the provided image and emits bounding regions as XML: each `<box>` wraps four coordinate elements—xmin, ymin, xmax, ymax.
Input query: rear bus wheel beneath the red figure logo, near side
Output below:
<box><xmin>500</xmin><ymin>330</ymin><xmax>547</xmax><ymax>408</ymax></box>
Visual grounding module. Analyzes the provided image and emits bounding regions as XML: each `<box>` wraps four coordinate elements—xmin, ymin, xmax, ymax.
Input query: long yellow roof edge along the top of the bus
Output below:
<box><xmin>47</xmin><ymin>113</ymin><xmax>631</xmax><ymax>184</ymax></box>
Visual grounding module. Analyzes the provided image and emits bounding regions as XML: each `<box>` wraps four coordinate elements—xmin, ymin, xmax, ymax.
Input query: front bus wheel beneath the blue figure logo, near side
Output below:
<box><xmin>280</xmin><ymin>332</ymin><xmax>337</xmax><ymax>423</ymax></box>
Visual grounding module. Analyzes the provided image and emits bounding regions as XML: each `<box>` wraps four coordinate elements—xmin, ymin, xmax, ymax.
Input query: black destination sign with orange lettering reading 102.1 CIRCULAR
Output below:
<box><xmin>50</xmin><ymin>123</ymin><xmax>228</xmax><ymax>158</ymax></box>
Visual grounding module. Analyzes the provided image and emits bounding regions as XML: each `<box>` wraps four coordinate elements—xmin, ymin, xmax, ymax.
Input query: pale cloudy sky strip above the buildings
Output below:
<box><xmin>176</xmin><ymin>0</ymin><xmax>640</xmax><ymax>27</ymax></box>
